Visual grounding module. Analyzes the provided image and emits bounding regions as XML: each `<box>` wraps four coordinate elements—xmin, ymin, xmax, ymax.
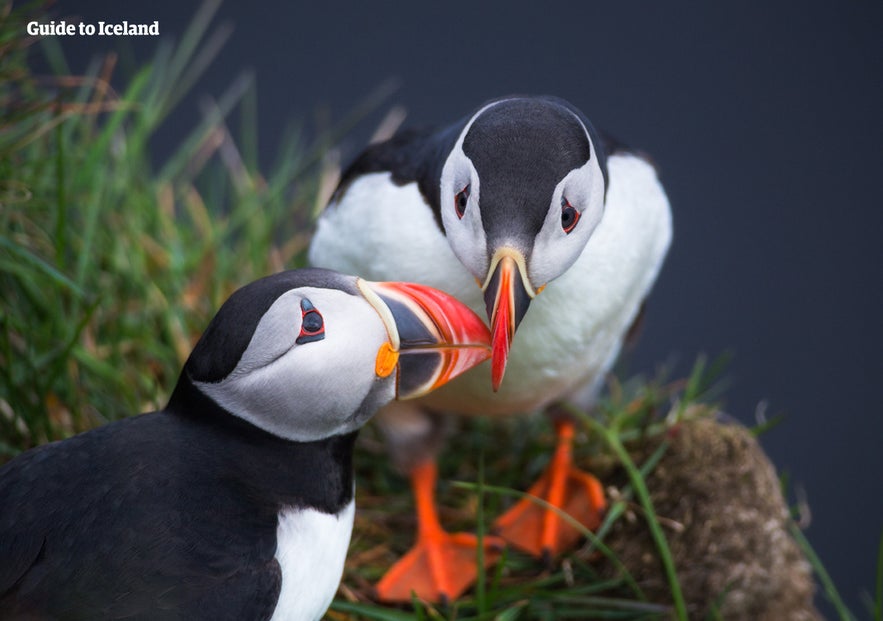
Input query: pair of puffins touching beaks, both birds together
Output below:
<box><xmin>0</xmin><ymin>97</ymin><xmax>671</xmax><ymax>620</ymax></box>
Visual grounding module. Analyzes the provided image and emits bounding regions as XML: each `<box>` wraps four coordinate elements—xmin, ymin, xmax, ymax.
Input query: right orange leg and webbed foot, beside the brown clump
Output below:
<box><xmin>494</xmin><ymin>420</ymin><xmax>606</xmax><ymax>558</ymax></box>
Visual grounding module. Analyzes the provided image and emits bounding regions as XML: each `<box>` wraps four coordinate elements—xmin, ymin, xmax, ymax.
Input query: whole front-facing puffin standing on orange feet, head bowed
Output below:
<box><xmin>309</xmin><ymin>95</ymin><xmax>672</xmax><ymax>601</ymax></box>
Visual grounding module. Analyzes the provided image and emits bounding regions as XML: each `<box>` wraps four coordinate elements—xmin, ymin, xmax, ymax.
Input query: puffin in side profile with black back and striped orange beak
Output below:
<box><xmin>0</xmin><ymin>269</ymin><xmax>490</xmax><ymax>621</ymax></box>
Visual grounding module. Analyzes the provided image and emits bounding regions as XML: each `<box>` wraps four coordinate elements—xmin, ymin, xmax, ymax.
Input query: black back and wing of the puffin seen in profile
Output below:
<box><xmin>0</xmin><ymin>413</ymin><xmax>281</xmax><ymax>619</ymax></box>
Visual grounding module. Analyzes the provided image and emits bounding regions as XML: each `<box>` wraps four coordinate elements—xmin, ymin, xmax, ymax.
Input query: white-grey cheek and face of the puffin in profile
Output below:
<box><xmin>196</xmin><ymin>287</ymin><xmax>395</xmax><ymax>442</ymax></box>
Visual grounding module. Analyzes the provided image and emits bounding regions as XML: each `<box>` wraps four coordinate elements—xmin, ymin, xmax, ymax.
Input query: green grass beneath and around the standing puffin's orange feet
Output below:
<box><xmin>332</xmin><ymin>364</ymin><xmax>711</xmax><ymax>620</ymax></box>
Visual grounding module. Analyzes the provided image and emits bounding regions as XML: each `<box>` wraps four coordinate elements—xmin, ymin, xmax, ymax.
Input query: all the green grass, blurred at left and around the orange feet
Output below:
<box><xmin>0</xmin><ymin>2</ymin><xmax>883</xmax><ymax>621</ymax></box>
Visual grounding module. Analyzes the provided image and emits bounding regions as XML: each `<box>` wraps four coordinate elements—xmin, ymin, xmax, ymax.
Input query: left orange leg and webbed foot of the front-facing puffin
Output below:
<box><xmin>377</xmin><ymin>461</ymin><xmax>504</xmax><ymax>602</ymax></box>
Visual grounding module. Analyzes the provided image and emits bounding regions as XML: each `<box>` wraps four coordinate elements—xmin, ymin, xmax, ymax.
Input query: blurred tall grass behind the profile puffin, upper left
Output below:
<box><xmin>0</xmin><ymin>2</ymin><xmax>327</xmax><ymax>458</ymax></box>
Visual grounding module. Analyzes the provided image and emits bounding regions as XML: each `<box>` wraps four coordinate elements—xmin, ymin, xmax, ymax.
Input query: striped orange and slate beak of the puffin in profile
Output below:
<box><xmin>359</xmin><ymin>280</ymin><xmax>491</xmax><ymax>400</ymax></box>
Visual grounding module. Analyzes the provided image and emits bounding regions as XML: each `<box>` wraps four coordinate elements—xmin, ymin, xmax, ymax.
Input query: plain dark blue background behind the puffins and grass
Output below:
<box><xmin>53</xmin><ymin>0</ymin><xmax>883</xmax><ymax>617</ymax></box>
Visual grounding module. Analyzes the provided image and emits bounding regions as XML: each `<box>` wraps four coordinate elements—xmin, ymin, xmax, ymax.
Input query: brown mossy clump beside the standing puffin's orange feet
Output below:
<box><xmin>605</xmin><ymin>417</ymin><xmax>821</xmax><ymax>621</ymax></box>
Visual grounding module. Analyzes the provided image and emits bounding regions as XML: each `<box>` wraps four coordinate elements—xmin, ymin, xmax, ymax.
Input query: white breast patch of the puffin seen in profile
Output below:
<box><xmin>271</xmin><ymin>500</ymin><xmax>356</xmax><ymax>621</ymax></box>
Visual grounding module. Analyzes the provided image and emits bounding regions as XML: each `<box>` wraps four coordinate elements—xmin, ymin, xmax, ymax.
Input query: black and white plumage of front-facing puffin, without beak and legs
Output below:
<box><xmin>310</xmin><ymin>97</ymin><xmax>671</xmax><ymax>428</ymax></box>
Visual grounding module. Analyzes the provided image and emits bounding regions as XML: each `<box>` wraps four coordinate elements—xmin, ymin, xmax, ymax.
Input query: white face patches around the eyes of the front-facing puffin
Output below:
<box><xmin>440</xmin><ymin>102</ymin><xmax>604</xmax><ymax>290</ymax></box>
